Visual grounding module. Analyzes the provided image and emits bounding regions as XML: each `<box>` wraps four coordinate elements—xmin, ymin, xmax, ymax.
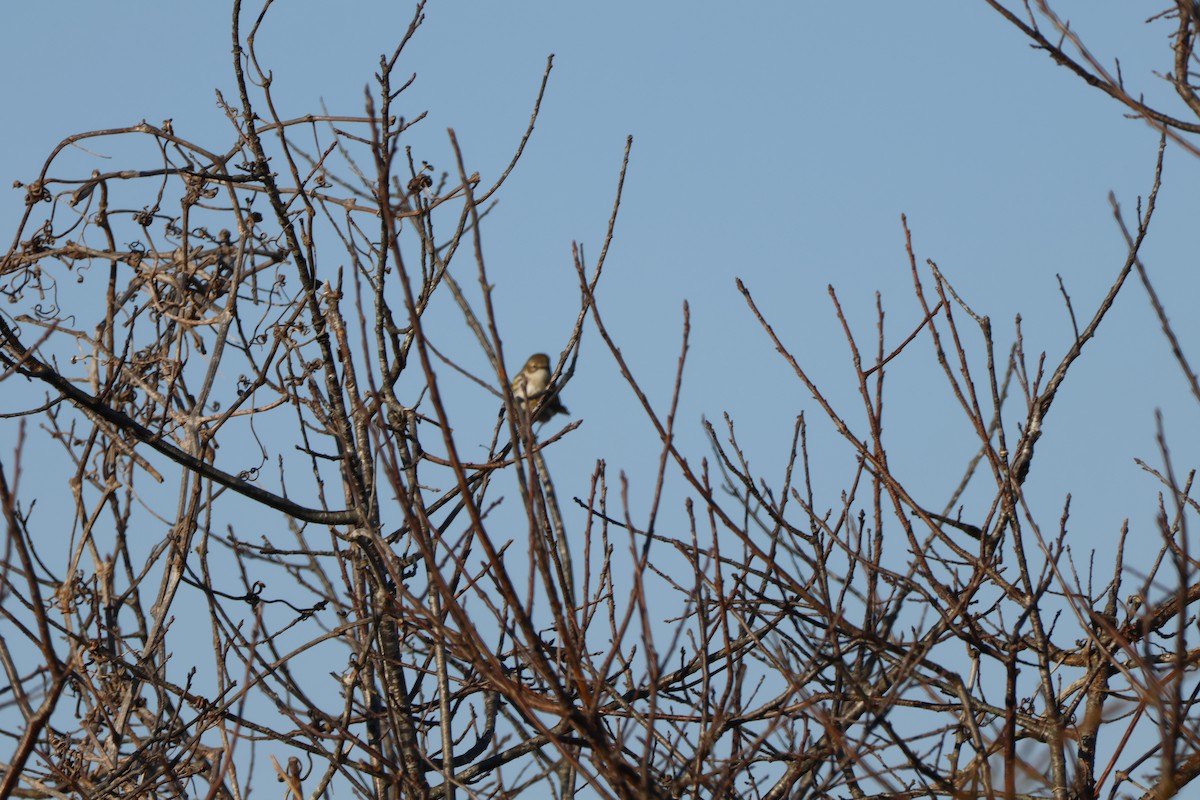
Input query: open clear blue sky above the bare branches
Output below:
<box><xmin>0</xmin><ymin>0</ymin><xmax>1200</xmax><ymax>782</ymax></box>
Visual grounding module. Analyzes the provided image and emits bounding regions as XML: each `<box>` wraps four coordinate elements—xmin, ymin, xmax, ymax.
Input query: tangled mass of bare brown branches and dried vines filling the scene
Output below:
<box><xmin>0</xmin><ymin>0</ymin><xmax>1200</xmax><ymax>800</ymax></box>
